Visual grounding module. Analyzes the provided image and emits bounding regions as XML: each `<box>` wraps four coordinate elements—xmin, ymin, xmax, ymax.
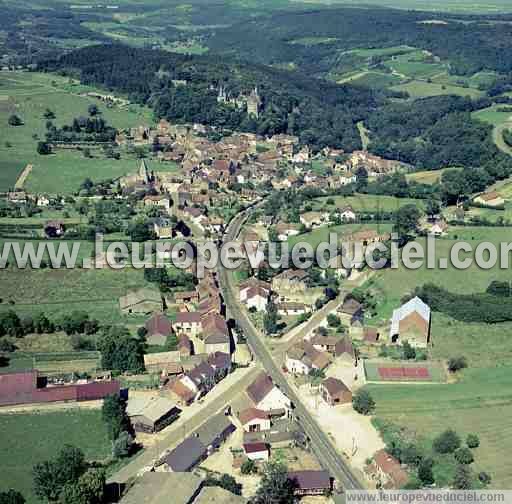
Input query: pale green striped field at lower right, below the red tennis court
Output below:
<box><xmin>367</xmin><ymin>366</ymin><xmax>512</xmax><ymax>488</ymax></box>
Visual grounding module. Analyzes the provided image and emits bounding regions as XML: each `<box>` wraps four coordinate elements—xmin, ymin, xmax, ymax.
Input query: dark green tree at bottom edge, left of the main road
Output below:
<box><xmin>254</xmin><ymin>462</ymin><xmax>295</xmax><ymax>504</ymax></box>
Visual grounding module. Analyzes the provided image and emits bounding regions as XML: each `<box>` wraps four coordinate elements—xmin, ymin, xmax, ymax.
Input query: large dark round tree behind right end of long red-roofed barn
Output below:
<box><xmin>98</xmin><ymin>326</ymin><xmax>144</xmax><ymax>373</ymax></box>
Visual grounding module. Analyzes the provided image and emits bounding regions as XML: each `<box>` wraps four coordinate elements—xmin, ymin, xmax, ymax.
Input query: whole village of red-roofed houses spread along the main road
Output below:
<box><xmin>0</xmin><ymin>89</ymin><xmax>478</xmax><ymax>504</ymax></box>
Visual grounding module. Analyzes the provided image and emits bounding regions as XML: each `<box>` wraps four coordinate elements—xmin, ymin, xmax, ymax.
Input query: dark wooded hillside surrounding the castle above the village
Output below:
<box><xmin>39</xmin><ymin>44</ymin><xmax>385</xmax><ymax>151</ymax></box>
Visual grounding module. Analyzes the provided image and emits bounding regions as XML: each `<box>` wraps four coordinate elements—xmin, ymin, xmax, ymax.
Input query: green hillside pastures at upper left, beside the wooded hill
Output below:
<box><xmin>0</xmin><ymin>72</ymin><xmax>152</xmax><ymax>193</ymax></box>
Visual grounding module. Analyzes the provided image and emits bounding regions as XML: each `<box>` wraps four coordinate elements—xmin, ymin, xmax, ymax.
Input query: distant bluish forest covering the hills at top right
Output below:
<box><xmin>206</xmin><ymin>7</ymin><xmax>512</xmax><ymax>75</ymax></box>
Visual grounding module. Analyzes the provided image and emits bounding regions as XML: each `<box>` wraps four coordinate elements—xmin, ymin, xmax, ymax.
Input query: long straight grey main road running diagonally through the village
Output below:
<box><xmin>218</xmin><ymin>205</ymin><xmax>364</xmax><ymax>501</ymax></box>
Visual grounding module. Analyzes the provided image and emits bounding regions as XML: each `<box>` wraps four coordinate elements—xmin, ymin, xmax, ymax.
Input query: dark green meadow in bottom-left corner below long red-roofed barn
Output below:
<box><xmin>0</xmin><ymin>410</ymin><xmax>110</xmax><ymax>504</ymax></box>
